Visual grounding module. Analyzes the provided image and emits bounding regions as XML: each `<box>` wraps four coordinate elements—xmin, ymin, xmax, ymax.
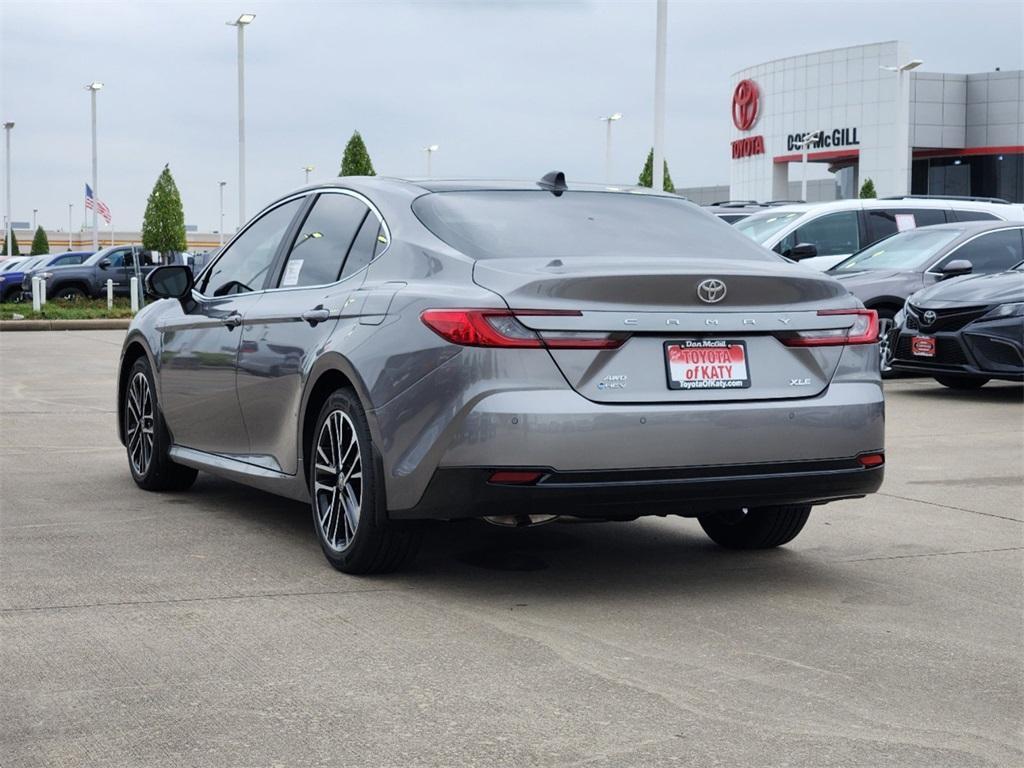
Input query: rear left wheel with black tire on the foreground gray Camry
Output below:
<box><xmin>306</xmin><ymin>388</ymin><xmax>422</xmax><ymax>573</ymax></box>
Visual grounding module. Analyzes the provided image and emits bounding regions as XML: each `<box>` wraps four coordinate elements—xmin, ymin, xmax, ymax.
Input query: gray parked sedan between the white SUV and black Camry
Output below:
<box><xmin>828</xmin><ymin>221</ymin><xmax>1024</xmax><ymax>373</ymax></box>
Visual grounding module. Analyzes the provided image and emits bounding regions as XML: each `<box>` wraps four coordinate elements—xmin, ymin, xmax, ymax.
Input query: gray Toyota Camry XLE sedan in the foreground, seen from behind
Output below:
<box><xmin>117</xmin><ymin>173</ymin><xmax>885</xmax><ymax>573</ymax></box>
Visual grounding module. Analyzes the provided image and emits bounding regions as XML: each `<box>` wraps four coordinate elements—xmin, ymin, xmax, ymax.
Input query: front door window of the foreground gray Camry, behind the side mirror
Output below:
<box><xmin>199</xmin><ymin>198</ymin><xmax>303</xmax><ymax>296</ymax></box>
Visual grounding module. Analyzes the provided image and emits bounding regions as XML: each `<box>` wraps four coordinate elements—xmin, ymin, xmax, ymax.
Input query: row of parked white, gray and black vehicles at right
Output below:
<box><xmin>709</xmin><ymin>196</ymin><xmax>1024</xmax><ymax>388</ymax></box>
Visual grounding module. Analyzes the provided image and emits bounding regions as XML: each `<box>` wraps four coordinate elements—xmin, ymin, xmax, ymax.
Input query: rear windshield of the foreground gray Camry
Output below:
<box><xmin>413</xmin><ymin>189</ymin><xmax>771</xmax><ymax>259</ymax></box>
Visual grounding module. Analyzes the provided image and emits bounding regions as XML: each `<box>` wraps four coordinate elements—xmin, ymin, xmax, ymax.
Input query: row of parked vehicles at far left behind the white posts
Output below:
<box><xmin>0</xmin><ymin>246</ymin><xmax>216</xmax><ymax>302</ymax></box>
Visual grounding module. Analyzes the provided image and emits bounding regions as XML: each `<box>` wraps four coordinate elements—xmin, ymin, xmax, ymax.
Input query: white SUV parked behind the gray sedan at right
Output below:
<box><xmin>735</xmin><ymin>196</ymin><xmax>1024</xmax><ymax>270</ymax></box>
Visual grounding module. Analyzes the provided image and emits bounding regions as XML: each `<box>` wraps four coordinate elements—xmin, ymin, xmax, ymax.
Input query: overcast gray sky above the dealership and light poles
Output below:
<box><xmin>0</xmin><ymin>0</ymin><xmax>1024</xmax><ymax>231</ymax></box>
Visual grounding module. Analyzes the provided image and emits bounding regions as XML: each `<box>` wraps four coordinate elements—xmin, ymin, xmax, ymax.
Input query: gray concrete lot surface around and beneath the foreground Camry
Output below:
<box><xmin>0</xmin><ymin>331</ymin><xmax>1024</xmax><ymax>768</ymax></box>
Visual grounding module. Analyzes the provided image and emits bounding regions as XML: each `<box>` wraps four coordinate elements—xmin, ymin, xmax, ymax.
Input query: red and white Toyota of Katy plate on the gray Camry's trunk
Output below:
<box><xmin>665</xmin><ymin>339</ymin><xmax>751</xmax><ymax>389</ymax></box>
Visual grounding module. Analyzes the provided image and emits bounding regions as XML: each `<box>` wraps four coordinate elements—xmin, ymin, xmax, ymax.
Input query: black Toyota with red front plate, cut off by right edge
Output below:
<box><xmin>893</xmin><ymin>263</ymin><xmax>1024</xmax><ymax>389</ymax></box>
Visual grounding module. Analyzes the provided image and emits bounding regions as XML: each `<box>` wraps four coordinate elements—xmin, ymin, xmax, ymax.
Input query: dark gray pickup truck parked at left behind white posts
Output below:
<box><xmin>22</xmin><ymin>246</ymin><xmax>163</xmax><ymax>300</ymax></box>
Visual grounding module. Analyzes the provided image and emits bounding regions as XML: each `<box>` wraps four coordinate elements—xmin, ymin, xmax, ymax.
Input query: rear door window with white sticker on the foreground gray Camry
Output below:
<box><xmin>279</xmin><ymin>195</ymin><xmax>377</xmax><ymax>288</ymax></box>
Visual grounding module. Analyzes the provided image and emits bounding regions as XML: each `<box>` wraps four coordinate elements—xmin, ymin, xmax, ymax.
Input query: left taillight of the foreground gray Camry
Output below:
<box><xmin>420</xmin><ymin>309</ymin><xmax>629</xmax><ymax>349</ymax></box>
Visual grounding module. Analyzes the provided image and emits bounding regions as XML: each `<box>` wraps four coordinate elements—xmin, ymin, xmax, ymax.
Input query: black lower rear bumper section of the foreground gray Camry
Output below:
<box><xmin>390</xmin><ymin>457</ymin><xmax>885</xmax><ymax>520</ymax></box>
